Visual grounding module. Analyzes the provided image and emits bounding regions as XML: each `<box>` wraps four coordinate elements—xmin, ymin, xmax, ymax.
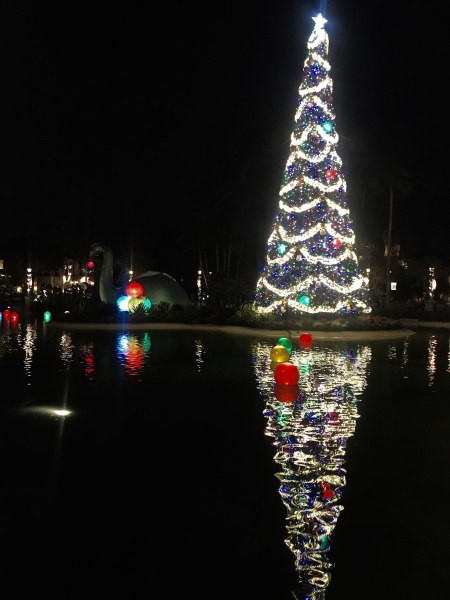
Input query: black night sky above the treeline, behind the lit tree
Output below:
<box><xmin>0</xmin><ymin>0</ymin><xmax>444</xmax><ymax>278</ymax></box>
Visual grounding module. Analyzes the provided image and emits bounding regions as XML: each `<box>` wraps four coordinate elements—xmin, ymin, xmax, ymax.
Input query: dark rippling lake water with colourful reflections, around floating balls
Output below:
<box><xmin>0</xmin><ymin>312</ymin><xmax>450</xmax><ymax>600</ymax></box>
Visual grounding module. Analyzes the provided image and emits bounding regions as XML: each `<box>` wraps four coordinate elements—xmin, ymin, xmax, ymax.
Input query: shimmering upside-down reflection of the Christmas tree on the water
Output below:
<box><xmin>252</xmin><ymin>343</ymin><xmax>372</xmax><ymax>600</ymax></box>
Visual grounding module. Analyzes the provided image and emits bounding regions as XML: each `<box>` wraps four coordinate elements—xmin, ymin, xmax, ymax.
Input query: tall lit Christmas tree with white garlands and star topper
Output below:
<box><xmin>255</xmin><ymin>14</ymin><xmax>371</xmax><ymax>314</ymax></box>
